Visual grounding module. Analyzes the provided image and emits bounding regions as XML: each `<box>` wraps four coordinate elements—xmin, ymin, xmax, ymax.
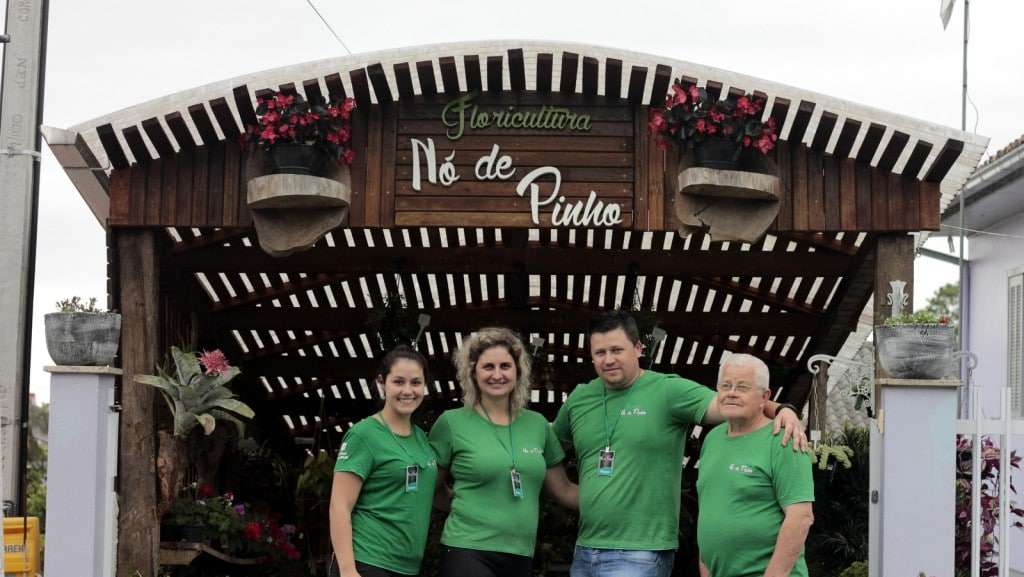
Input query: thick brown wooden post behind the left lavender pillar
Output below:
<box><xmin>117</xmin><ymin>230</ymin><xmax>160</xmax><ymax>577</ymax></box>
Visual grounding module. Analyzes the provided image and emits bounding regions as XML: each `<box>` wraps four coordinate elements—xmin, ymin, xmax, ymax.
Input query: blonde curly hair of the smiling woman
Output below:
<box><xmin>455</xmin><ymin>327</ymin><xmax>530</xmax><ymax>413</ymax></box>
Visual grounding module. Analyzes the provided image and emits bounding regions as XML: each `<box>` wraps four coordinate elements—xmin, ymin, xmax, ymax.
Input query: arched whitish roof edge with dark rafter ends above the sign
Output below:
<box><xmin>44</xmin><ymin>40</ymin><xmax>988</xmax><ymax>224</ymax></box>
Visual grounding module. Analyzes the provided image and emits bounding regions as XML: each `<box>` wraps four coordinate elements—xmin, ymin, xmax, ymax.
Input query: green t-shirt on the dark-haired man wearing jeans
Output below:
<box><xmin>554</xmin><ymin>371</ymin><xmax>715</xmax><ymax>550</ymax></box>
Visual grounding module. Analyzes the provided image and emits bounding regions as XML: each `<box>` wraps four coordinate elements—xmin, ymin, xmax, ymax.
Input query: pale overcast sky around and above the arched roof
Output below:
<box><xmin>0</xmin><ymin>0</ymin><xmax>1024</xmax><ymax>400</ymax></box>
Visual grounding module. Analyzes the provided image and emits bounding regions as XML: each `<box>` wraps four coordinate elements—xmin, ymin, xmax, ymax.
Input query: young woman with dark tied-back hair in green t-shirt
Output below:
<box><xmin>331</xmin><ymin>346</ymin><xmax>437</xmax><ymax>577</ymax></box>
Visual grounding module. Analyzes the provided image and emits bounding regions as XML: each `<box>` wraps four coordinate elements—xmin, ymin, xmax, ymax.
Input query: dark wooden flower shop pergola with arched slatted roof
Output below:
<box><xmin>44</xmin><ymin>42</ymin><xmax>986</xmax><ymax>574</ymax></box>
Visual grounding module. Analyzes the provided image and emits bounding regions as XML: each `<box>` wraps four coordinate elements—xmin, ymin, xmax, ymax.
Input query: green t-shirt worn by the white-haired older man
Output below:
<box><xmin>697</xmin><ymin>422</ymin><xmax>814</xmax><ymax>577</ymax></box>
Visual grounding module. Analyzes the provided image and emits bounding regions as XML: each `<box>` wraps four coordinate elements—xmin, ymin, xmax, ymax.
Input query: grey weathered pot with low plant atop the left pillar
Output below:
<box><xmin>43</xmin><ymin>296</ymin><xmax>121</xmax><ymax>367</ymax></box>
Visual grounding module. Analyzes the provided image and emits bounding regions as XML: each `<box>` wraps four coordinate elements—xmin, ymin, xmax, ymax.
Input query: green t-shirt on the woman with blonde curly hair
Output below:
<box><xmin>430</xmin><ymin>407</ymin><xmax>565</xmax><ymax>557</ymax></box>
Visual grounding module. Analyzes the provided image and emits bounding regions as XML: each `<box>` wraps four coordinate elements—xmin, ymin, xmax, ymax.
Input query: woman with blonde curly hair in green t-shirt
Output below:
<box><xmin>430</xmin><ymin>328</ymin><xmax>579</xmax><ymax>577</ymax></box>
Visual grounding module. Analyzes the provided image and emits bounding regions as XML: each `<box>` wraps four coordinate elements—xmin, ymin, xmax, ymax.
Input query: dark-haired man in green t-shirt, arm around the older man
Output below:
<box><xmin>554</xmin><ymin>311</ymin><xmax>807</xmax><ymax>577</ymax></box>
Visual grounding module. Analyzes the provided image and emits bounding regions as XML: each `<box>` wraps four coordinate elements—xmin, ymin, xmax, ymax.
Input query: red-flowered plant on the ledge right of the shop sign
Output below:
<box><xmin>647</xmin><ymin>80</ymin><xmax>778</xmax><ymax>154</ymax></box>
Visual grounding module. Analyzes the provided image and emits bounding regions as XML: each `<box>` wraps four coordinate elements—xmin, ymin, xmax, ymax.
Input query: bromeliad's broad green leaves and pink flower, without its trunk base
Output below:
<box><xmin>135</xmin><ymin>346</ymin><xmax>255</xmax><ymax>439</ymax></box>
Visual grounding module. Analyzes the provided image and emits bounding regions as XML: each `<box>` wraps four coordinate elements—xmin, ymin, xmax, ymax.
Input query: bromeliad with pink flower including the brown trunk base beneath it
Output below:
<box><xmin>135</xmin><ymin>346</ymin><xmax>255</xmax><ymax>503</ymax></box>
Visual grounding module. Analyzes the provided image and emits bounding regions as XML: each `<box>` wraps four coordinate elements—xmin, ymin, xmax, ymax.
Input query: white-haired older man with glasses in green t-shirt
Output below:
<box><xmin>697</xmin><ymin>355</ymin><xmax>814</xmax><ymax>577</ymax></box>
